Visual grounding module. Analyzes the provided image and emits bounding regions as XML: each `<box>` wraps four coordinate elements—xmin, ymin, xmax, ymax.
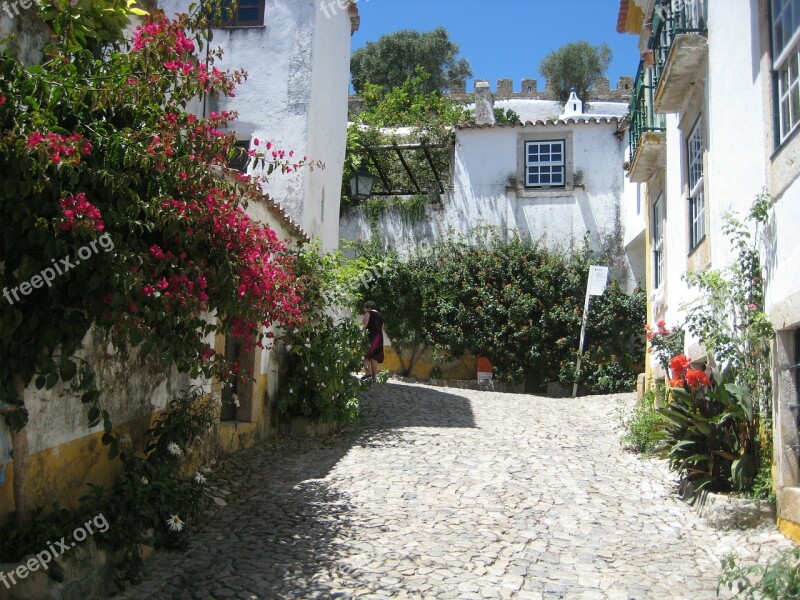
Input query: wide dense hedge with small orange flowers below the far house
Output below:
<box><xmin>356</xmin><ymin>238</ymin><xmax>644</xmax><ymax>391</ymax></box>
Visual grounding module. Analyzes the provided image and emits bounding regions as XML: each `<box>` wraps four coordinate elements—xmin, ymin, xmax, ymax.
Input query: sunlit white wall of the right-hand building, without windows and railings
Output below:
<box><xmin>620</xmin><ymin>0</ymin><xmax>800</xmax><ymax>539</ymax></box>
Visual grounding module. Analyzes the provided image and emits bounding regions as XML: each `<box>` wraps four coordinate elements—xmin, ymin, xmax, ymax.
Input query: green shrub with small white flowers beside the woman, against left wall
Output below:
<box><xmin>278</xmin><ymin>244</ymin><xmax>369</xmax><ymax>424</ymax></box>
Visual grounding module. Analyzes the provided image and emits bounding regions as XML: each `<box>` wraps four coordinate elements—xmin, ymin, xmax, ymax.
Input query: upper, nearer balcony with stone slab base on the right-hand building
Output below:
<box><xmin>651</xmin><ymin>0</ymin><xmax>708</xmax><ymax>113</ymax></box>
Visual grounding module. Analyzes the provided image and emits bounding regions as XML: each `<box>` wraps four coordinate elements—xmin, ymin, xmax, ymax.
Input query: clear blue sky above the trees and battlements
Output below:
<box><xmin>352</xmin><ymin>0</ymin><xmax>639</xmax><ymax>91</ymax></box>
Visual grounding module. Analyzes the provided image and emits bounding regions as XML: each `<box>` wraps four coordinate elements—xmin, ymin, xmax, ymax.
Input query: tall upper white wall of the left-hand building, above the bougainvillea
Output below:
<box><xmin>159</xmin><ymin>0</ymin><xmax>355</xmax><ymax>250</ymax></box>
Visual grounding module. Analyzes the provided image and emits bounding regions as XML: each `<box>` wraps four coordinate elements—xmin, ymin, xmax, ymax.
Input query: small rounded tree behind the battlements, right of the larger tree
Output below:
<box><xmin>539</xmin><ymin>41</ymin><xmax>612</xmax><ymax>103</ymax></box>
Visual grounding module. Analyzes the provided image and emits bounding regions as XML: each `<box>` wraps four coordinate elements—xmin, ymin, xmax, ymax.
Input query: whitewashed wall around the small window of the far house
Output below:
<box><xmin>340</xmin><ymin>119</ymin><xmax>632</xmax><ymax>284</ymax></box>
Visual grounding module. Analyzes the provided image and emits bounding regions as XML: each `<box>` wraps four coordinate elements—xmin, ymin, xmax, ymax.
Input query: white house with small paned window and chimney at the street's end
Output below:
<box><xmin>340</xmin><ymin>82</ymin><xmax>644</xmax><ymax>287</ymax></box>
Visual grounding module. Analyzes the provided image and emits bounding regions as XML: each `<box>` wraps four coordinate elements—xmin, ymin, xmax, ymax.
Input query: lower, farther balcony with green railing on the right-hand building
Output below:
<box><xmin>629</xmin><ymin>61</ymin><xmax>666</xmax><ymax>183</ymax></box>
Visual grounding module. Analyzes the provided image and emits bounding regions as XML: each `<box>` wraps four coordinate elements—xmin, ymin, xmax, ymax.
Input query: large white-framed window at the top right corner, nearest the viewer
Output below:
<box><xmin>772</xmin><ymin>0</ymin><xmax>800</xmax><ymax>143</ymax></box>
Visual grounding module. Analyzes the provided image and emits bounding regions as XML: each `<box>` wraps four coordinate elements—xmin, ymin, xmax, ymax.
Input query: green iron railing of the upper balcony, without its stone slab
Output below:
<box><xmin>650</xmin><ymin>0</ymin><xmax>708</xmax><ymax>85</ymax></box>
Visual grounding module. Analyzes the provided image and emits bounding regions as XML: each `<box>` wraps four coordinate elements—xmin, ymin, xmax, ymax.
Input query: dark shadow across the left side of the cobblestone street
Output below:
<box><xmin>112</xmin><ymin>383</ymin><xmax>476</xmax><ymax>600</ymax></box>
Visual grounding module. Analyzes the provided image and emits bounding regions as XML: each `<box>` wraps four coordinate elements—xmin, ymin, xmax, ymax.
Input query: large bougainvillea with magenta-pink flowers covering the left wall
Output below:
<box><xmin>0</xmin><ymin>0</ymin><xmax>305</xmax><ymax>440</ymax></box>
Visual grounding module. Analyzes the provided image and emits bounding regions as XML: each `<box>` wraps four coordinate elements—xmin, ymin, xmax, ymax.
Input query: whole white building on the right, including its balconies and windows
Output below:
<box><xmin>617</xmin><ymin>0</ymin><xmax>800</xmax><ymax>540</ymax></box>
